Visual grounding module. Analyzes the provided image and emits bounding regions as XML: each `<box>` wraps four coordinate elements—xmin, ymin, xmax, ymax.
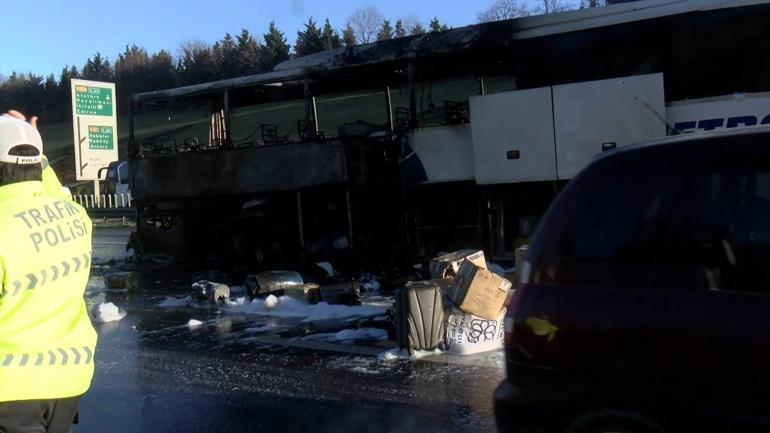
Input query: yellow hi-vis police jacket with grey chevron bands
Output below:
<box><xmin>0</xmin><ymin>181</ymin><xmax>96</xmax><ymax>402</ymax></box>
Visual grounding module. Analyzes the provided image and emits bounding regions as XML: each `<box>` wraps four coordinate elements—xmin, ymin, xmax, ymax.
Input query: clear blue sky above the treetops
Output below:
<box><xmin>0</xmin><ymin>0</ymin><xmax>492</xmax><ymax>76</ymax></box>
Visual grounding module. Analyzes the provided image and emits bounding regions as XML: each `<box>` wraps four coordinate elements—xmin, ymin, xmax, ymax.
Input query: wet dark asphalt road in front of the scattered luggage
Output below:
<box><xmin>75</xmin><ymin>229</ymin><xmax>503</xmax><ymax>433</ymax></box>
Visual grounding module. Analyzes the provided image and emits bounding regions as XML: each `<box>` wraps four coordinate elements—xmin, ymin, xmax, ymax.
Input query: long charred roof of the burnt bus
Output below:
<box><xmin>132</xmin><ymin>0</ymin><xmax>770</xmax><ymax>104</ymax></box>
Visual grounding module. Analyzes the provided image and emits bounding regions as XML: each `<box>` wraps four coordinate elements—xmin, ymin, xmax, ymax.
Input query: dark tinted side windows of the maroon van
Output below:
<box><xmin>535</xmin><ymin>142</ymin><xmax>770</xmax><ymax>293</ymax></box>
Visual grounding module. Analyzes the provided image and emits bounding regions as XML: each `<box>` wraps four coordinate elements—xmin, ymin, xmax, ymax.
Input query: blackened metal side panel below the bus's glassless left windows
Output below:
<box><xmin>130</xmin><ymin>142</ymin><xmax>347</xmax><ymax>201</ymax></box>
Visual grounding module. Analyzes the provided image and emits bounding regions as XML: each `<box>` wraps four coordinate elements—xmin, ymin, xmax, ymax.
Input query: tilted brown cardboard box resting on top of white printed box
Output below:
<box><xmin>450</xmin><ymin>260</ymin><xmax>512</xmax><ymax>320</ymax></box>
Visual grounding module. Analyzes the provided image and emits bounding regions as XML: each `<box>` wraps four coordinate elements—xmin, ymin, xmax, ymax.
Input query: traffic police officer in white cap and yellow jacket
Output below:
<box><xmin>0</xmin><ymin>116</ymin><xmax>96</xmax><ymax>433</ymax></box>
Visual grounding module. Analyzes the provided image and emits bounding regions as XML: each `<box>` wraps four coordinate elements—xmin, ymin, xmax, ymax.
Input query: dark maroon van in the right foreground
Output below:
<box><xmin>494</xmin><ymin>127</ymin><xmax>770</xmax><ymax>433</ymax></box>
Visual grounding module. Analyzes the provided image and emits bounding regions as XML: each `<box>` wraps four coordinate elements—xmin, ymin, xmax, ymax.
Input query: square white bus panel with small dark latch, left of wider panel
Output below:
<box><xmin>470</xmin><ymin>87</ymin><xmax>556</xmax><ymax>184</ymax></box>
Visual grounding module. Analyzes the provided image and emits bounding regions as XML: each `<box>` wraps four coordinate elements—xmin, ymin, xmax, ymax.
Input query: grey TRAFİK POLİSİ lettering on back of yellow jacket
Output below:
<box><xmin>13</xmin><ymin>200</ymin><xmax>88</xmax><ymax>252</ymax></box>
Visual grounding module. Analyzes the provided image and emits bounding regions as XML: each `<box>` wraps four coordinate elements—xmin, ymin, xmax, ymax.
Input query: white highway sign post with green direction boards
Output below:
<box><xmin>72</xmin><ymin>80</ymin><xmax>118</xmax><ymax>201</ymax></box>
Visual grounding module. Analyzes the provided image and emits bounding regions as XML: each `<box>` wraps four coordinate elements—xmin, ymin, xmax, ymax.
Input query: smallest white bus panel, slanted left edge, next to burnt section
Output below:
<box><xmin>409</xmin><ymin>125</ymin><xmax>473</xmax><ymax>182</ymax></box>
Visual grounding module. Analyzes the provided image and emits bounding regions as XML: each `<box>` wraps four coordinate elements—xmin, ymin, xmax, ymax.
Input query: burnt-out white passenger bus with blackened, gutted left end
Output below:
<box><xmin>129</xmin><ymin>0</ymin><xmax>770</xmax><ymax>266</ymax></box>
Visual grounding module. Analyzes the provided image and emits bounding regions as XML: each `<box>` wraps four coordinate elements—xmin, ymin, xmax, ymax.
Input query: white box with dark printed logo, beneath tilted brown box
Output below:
<box><xmin>445</xmin><ymin>305</ymin><xmax>506</xmax><ymax>355</ymax></box>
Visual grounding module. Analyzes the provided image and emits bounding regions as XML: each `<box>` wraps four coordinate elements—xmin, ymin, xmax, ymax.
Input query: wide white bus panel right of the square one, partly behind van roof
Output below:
<box><xmin>553</xmin><ymin>74</ymin><xmax>666</xmax><ymax>179</ymax></box>
